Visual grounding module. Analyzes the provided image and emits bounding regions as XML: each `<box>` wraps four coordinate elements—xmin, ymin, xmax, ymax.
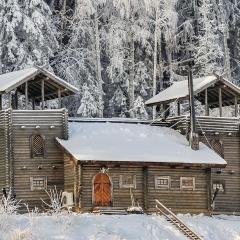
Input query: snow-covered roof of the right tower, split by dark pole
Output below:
<box><xmin>146</xmin><ymin>75</ymin><xmax>240</xmax><ymax>105</ymax></box>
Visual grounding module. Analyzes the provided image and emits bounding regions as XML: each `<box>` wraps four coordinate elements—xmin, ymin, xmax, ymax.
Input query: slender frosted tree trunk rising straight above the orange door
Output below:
<box><xmin>94</xmin><ymin>13</ymin><xmax>103</xmax><ymax>117</ymax></box>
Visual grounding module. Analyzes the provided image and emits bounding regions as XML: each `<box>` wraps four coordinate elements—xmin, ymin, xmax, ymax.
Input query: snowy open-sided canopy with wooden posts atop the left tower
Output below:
<box><xmin>0</xmin><ymin>67</ymin><xmax>78</xmax><ymax>109</ymax></box>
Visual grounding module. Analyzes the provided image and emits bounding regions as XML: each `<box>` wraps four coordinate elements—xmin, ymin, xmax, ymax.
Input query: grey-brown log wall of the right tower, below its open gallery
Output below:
<box><xmin>168</xmin><ymin>116</ymin><xmax>240</xmax><ymax>213</ymax></box>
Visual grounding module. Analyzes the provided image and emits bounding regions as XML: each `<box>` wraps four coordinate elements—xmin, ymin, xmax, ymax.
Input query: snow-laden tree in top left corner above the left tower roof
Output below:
<box><xmin>0</xmin><ymin>0</ymin><xmax>58</xmax><ymax>73</ymax></box>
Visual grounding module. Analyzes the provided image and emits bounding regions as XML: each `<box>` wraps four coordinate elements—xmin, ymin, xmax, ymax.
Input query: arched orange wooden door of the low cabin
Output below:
<box><xmin>94</xmin><ymin>173</ymin><xmax>112</xmax><ymax>207</ymax></box>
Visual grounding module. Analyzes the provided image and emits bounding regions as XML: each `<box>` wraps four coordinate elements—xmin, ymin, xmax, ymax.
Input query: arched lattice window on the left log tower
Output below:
<box><xmin>30</xmin><ymin>134</ymin><xmax>45</xmax><ymax>158</ymax></box>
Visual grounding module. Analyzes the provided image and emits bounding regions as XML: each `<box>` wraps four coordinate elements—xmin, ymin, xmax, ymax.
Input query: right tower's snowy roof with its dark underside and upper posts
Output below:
<box><xmin>146</xmin><ymin>75</ymin><xmax>240</xmax><ymax>108</ymax></box>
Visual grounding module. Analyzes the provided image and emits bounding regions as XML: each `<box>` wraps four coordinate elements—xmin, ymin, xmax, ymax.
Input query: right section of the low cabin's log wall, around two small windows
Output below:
<box><xmin>148</xmin><ymin>166</ymin><xmax>210</xmax><ymax>213</ymax></box>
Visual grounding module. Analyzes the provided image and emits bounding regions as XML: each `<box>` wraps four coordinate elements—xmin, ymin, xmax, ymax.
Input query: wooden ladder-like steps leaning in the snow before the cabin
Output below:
<box><xmin>156</xmin><ymin>200</ymin><xmax>203</xmax><ymax>240</ymax></box>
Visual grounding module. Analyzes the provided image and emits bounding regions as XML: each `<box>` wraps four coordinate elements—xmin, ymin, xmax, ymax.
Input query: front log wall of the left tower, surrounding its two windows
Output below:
<box><xmin>12</xmin><ymin>110</ymin><xmax>67</xmax><ymax>211</ymax></box>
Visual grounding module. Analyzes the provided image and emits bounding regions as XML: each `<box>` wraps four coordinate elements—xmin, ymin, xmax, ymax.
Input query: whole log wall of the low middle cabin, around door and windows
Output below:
<box><xmin>64</xmin><ymin>162</ymin><xmax>210</xmax><ymax>212</ymax></box>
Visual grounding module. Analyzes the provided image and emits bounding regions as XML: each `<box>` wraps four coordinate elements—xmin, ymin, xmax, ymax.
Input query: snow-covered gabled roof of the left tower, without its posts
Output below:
<box><xmin>0</xmin><ymin>67</ymin><xmax>78</xmax><ymax>94</ymax></box>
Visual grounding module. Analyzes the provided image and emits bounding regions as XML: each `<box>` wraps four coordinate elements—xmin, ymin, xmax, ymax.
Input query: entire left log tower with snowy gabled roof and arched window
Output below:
<box><xmin>0</xmin><ymin>68</ymin><xmax>78</xmax><ymax>210</ymax></box>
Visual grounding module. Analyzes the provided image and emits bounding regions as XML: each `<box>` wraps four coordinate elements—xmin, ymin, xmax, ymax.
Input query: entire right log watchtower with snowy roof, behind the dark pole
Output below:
<box><xmin>146</xmin><ymin>75</ymin><xmax>240</xmax><ymax>213</ymax></box>
